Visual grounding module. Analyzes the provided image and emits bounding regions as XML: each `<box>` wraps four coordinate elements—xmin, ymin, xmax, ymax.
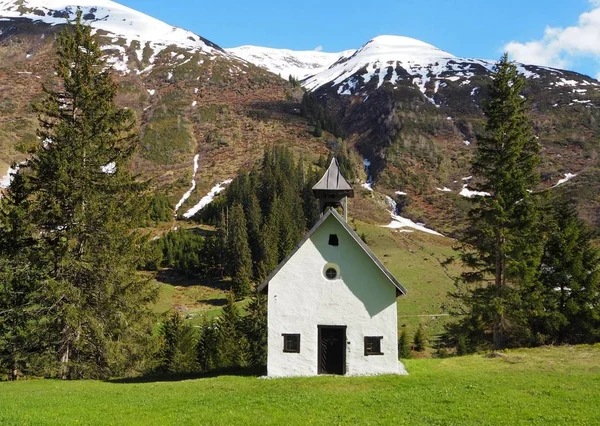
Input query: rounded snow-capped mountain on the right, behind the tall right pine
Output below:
<box><xmin>302</xmin><ymin>36</ymin><xmax>600</xmax><ymax>229</ymax></box>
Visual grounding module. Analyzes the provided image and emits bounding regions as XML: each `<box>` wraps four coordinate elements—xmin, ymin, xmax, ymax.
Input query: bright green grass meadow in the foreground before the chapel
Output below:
<box><xmin>0</xmin><ymin>345</ymin><xmax>600</xmax><ymax>425</ymax></box>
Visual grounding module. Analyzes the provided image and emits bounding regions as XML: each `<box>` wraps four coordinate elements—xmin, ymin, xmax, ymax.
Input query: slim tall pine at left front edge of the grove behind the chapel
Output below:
<box><xmin>229</xmin><ymin>204</ymin><xmax>252</xmax><ymax>300</ymax></box>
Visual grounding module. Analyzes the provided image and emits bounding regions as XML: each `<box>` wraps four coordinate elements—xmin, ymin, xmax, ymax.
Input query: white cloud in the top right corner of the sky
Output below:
<box><xmin>504</xmin><ymin>0</ymin><xmax>600</xmax><ymax>74</ymax></box>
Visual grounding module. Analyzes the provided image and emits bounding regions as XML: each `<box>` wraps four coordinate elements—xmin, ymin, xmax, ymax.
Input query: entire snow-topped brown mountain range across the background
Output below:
<box><xmin>0</xmin><ymin>0</ymin><xmax>600</xmax><ymax>234</ymax></box>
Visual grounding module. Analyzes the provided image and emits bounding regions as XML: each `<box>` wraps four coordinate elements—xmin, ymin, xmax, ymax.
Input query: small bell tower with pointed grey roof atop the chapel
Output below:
<box><xmin>313</xmin><ymin>157</ymin><xmax>354</xmax><ymax>222</ymax></box>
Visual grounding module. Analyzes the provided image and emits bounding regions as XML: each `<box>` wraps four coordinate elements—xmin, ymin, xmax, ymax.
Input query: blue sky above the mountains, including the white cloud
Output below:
<box><xmin>117</xmin><ymin>0</ymin><xmax>600</xmax><ymax>76</ymax></box>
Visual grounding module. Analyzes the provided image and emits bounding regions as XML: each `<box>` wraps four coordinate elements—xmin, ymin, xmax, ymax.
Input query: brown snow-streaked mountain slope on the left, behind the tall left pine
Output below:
<box><xmin>0</xmin><ymin>0</ymin><xmax>326</xmax><ymax>218</ymax></box>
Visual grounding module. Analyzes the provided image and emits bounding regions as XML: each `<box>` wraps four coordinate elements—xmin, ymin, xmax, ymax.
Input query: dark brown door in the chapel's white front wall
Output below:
<box><xmin>319</xmin><ymin>325</ymin><xmax>346</xmax><ymax>375</ymax></box>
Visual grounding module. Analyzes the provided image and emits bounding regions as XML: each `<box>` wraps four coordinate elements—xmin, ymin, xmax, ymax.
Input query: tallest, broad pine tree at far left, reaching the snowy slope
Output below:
<box><xmin>2</xmin><ymin>12</ymin><xmax>155</xmax><ymax>378</ymax></box>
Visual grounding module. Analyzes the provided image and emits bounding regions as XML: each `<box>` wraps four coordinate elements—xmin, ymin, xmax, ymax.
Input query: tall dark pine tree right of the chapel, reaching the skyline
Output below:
<box><xmin>456</xmin><ymin>55</ymin><xmax>541</xmax><ymax>349</ymax></box>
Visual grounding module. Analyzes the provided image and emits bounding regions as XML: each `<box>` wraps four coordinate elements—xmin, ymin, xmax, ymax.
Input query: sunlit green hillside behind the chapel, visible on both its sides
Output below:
<box><xmin>154</xmin><ymin>212</ymin><xmax>460</xmax><ymax>346</ymax></box>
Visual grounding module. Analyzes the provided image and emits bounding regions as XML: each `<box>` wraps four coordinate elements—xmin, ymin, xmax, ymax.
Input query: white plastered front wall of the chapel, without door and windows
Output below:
<box><xmin>268</xmin><ymin>216</ymin><xmax>398</xmax><ymax>376</ymax></box>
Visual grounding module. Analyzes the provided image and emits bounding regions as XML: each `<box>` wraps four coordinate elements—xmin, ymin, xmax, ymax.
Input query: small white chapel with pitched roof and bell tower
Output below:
<box><xmin>258</xmin><ymin>158</ymin><xmax>406</xmax><ymax>377</ymax></box>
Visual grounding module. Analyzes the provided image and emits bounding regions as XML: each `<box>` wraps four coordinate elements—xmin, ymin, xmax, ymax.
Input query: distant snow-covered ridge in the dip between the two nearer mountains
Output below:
<box><xmin>225</xmin><ymin>46</ymin><xmax>355</xmax><ymax>80</ymax></box>
